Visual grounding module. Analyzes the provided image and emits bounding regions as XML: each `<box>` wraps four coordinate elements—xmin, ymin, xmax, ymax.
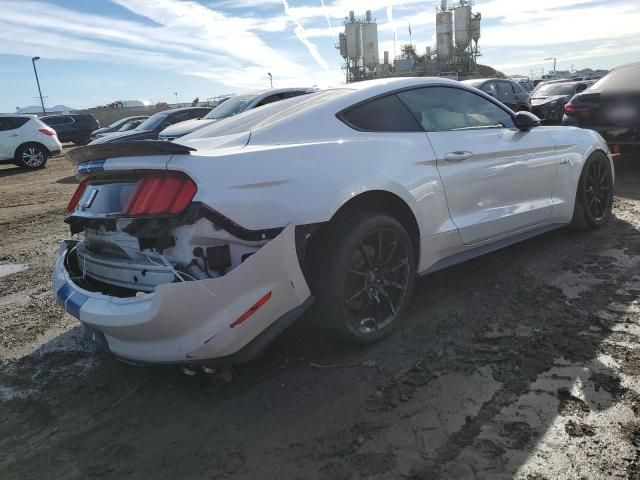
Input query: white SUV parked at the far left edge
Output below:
<box><xmin>0</xmin><ymin>115</ymin><xmax>62</xmax><ymax>170</ymax></box>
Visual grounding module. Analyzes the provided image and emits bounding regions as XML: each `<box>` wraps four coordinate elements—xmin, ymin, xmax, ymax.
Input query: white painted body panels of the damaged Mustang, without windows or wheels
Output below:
<box><xmin>54</xmin><ymin>78</ymin><xmax>613</xmax><ymax>363</ymax></box>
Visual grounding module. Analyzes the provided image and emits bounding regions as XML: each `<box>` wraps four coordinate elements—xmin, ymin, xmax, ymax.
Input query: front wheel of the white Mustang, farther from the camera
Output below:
<box><xmin>571</xmin><ymin>151</ymin><xmax>613</xmax><ymax>229</ymax></box>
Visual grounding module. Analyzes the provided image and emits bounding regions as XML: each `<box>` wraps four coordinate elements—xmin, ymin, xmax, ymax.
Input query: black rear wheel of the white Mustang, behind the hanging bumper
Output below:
<box><xmin>318</xmin><ymin>212</ymin><xmax>415</xmax><ymax>344</ymax></box>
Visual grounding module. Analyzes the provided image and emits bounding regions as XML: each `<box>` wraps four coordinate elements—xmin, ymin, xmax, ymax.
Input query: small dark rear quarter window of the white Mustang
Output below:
<box><xmin>338</xmin><ymin>95</ymin><xmax>422</xmax><ymax>132</ymax></box>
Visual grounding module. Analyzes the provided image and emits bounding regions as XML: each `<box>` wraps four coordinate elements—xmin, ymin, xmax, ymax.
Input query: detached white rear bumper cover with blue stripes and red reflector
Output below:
<box><xmin>53</xmin><ymin>225</ymin><xmax>312</xmax><ymax>363</ymax></box>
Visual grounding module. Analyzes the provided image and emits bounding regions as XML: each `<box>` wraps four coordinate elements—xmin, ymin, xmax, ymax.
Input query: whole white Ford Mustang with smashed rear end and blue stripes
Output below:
<box><xmin>54</xmin><ymin>78</ymin><xmax>614</xmax><ymax>364</ymax></box>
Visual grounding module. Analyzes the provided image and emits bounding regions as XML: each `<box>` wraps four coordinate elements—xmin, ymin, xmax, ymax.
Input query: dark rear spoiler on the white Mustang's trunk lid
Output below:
<box><xmin>65</xmin><ymin>140</ymin><xmax>196</xmax><ymax>165</ymax></box>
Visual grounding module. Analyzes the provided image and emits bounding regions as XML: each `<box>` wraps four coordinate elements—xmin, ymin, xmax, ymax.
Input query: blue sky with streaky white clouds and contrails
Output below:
<box><xmin>0</xmin><ymin>0</ymin><xmax>640</xmax><ymax>112</ymax></box>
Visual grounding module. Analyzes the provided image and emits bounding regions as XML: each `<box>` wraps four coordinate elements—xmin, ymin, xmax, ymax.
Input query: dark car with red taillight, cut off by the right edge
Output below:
<box><xmin>562</xmin><ymin>62</ymin><xmax>640</xmax><ymax>153</ymax></box>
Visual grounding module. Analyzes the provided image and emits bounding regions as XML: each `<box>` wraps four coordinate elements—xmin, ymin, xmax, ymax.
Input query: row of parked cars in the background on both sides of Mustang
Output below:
<box><xmin>0</xmin><ymin>63</ymin><xmax>640</xmax><ymax>169</ymax></box>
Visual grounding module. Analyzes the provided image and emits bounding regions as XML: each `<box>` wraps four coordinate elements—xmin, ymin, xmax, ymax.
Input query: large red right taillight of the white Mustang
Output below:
<box><xmin>124</xmin><ymin>173</ymin><xmax>197</xmax><ymax>216</ymax></box>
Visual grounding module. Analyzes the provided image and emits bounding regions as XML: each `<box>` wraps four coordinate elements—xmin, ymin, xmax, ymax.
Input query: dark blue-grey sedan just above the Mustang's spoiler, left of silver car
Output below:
<box><xmin>91</xmin><ymin>107</ymin><xmax>211</xmax><ymax>145</ymax></box>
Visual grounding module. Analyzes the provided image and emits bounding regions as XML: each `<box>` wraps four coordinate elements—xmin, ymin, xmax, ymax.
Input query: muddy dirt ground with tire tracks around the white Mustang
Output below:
<box><xmin>0</xmin><ymin>148</ymin><xmax>640</xmax><ymax>480</ymax></box>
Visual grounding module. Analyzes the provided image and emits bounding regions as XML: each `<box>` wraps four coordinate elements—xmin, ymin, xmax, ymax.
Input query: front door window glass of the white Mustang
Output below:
<box><xmin>398</xmin><ymin>87</ymin><xmax>514</xmax><ymax>132</ymax></box>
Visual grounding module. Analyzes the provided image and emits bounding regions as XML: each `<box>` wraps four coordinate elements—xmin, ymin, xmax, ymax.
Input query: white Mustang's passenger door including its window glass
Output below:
<box><xmin>399</xmin><ymin>86</ymin><xmax>557</xmax><ymax>245</ymax></box>
